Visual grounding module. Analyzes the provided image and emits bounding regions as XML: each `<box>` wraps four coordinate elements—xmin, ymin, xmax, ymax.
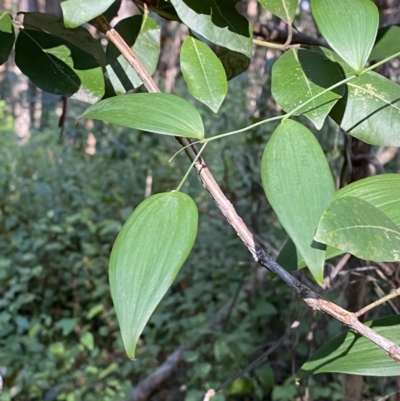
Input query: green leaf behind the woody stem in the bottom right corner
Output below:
<box><xmin>296</xmin><ymin>316</ymin><xmax>400</xmax><ymax>380</ymax></box>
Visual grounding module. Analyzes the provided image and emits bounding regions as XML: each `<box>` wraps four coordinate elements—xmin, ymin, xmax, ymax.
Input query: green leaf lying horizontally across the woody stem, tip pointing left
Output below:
<box><xmin>80</xmin><ymin>93</ymin><xmax>204</xmax><ymax>140</ymax></box>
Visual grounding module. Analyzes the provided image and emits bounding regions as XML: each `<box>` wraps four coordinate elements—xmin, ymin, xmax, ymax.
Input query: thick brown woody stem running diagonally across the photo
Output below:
<box><xmin>96</xmin><ymin>17</ymin><xmax>400</xmax><ymax>362</ymax></box>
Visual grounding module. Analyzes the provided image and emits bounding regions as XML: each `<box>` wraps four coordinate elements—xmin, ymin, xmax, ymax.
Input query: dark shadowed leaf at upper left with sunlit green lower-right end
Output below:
<box><xmin>15</xmin><ymin>24</ymin><xmax>104</xmax><ymax>103</ymax></box>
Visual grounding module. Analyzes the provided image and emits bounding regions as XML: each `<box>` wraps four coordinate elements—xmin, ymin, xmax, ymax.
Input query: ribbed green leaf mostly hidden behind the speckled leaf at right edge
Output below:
<box><xmin>276</xmin><ymin>174</ymin><xmax>400</xmax><ymax>271</ymax></box>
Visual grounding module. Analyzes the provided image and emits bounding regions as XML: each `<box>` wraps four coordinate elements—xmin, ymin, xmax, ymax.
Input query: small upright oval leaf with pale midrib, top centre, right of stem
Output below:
<box><xmin>180</xmin><ymin>36</ymin><xmax>228</xmax><ymax>113</ymax></box>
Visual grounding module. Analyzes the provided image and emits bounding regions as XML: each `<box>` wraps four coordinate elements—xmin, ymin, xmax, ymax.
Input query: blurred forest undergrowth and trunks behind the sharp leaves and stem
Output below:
<box><xmin>0</xmin><ymin>2</ymin><xmax>400</xmax><ymax>401</ymax></box>
